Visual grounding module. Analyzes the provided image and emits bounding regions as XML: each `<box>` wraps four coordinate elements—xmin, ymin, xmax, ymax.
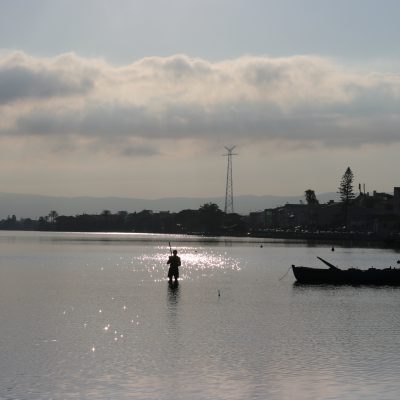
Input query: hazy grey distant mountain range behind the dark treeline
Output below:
<box><xmin>0</xmin><ymin>193</ymin><xmax>338</xmax><ymax>219</ymax></box>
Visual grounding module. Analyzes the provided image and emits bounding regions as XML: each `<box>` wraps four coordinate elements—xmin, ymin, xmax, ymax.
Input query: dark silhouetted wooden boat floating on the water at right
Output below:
<box><xmin>292</xmin><ymin>257</ymin><xmax>400</xmax><ymax>286</ymax></box>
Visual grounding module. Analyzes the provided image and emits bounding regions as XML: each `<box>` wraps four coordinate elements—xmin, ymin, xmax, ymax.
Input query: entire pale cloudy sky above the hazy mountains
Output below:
<box><xmin>0</xmin><ymin>0</ymin><xmax>400</xmax><ymax>199</ymax></box>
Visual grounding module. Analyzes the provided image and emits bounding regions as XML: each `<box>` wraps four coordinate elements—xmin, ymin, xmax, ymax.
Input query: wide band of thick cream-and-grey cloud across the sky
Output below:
<box><xmin>0</xmin><ymin>53</ymin><xmax>400</xmax><ymax>156</ymax></box>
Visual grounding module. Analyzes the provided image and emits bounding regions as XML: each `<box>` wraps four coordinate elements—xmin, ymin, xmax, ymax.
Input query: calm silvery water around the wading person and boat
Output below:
<box><xmin>0</xmin><ymin>232</ymin><xmax>400</xmax><ymax>400</ymax></box>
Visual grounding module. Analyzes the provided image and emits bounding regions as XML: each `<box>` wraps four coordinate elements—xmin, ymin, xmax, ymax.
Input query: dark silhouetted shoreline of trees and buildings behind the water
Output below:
<box><xmin>0</xmin><ymin>167</ymin><xmax>400</xmax><ymax>246</ymax></box>
